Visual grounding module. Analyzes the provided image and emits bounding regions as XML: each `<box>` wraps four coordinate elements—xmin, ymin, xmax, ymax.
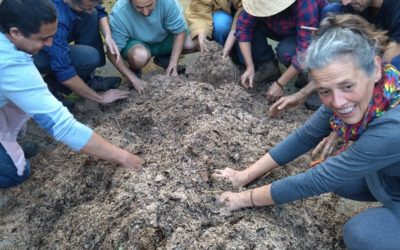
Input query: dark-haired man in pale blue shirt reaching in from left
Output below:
<box><xmin>0</xmin><ymin>0</ymin><xmax>141</xmax><ymax>188</ymax></box>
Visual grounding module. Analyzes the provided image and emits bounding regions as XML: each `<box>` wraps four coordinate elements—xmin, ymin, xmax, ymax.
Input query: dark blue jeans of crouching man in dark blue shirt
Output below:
<box><xmin>33</xmin><ymin>9</ymin><xmax>106</xmax><ymax>94</ymax></box>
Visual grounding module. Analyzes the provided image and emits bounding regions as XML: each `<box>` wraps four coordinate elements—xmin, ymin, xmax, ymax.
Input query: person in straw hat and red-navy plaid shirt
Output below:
<box><xmin>236</xmin><ymin>0</ymin><xmax>327</xmax><ymax>102</ymax></box>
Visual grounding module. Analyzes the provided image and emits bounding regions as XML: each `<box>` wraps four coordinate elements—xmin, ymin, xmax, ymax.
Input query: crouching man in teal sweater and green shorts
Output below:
<box><xmin>109</xmin><ymin>0</ymin><xmax>195</xmax><ymax>93</ymax></box>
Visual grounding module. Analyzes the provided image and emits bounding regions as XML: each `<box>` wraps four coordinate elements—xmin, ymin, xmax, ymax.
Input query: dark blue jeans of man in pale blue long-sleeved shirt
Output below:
<box><xmin>0</xmin><ymin>144</ymin><xmax>31</xmax><ymax>188</ymax></box>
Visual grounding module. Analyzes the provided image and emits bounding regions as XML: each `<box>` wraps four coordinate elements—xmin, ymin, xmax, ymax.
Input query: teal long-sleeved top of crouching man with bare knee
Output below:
<box><xmin>109</xmin><ymin>0</ymin><xmax>187</xmax><ymax>50</ymax></box>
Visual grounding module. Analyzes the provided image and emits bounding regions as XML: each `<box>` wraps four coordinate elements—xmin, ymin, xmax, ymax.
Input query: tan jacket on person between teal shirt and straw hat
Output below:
<box><xmin>185</xmin><ymin>0</ymin><xmax>243</xmax><ymax>38</ymax></box>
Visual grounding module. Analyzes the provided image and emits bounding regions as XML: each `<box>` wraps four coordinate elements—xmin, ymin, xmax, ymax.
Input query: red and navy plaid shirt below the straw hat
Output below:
<box><xmin>236</xmin><ymin>0</ymin><xmax>328</xmax><ymax>69</ymax></box>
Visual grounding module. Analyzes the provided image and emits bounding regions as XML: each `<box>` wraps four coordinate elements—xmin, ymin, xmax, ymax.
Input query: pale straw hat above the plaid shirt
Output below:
<box><xmin>242</xmin><ymin>0</ymin><xmax>296</xmax><ymax>17</ymax></box>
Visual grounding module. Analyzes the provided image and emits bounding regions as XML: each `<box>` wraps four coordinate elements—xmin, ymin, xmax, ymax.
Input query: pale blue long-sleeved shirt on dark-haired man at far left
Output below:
<box><xmin>0</xmin><ymin>33</ymin><xmax>93</xmax><ymax>150</ymax></box>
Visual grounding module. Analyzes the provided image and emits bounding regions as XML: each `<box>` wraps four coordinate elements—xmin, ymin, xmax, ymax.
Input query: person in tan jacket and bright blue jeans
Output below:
<box><xmin>186</xmin><ymin>0</ymin><xmax>243</xmax><ymax>57</ymax></box>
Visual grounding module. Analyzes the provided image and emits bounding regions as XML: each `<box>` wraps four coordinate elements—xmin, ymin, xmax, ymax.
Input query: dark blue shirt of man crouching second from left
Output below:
<box><xmin>44</xmin><ymin>0</ymin><xmax>107</xmax><ymax>82</ymax></box>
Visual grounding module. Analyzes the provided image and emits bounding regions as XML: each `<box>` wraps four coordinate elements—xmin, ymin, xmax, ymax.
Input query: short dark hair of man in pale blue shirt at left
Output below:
<box><xmin>0</xmin><ymin>0</ymin><xmax>57</xmax><ymax>37</ymax></box>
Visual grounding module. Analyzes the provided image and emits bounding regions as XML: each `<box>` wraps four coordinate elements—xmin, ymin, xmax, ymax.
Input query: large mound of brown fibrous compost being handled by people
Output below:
<box><xmin>0</xmin><ymin>42</ymin><xmax>376</xmax><ymax>249</ymax></box>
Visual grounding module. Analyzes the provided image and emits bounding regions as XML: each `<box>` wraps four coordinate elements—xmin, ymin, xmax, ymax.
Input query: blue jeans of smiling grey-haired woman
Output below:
<box><xmin>335</xmin><ymin>179</ymin><xmax>400</xmax><ymax>249</ymax></box>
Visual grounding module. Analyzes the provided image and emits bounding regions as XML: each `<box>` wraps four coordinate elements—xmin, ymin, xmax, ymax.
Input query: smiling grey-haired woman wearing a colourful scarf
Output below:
<box><xmin>215</xmin><ymin>15</ymin><xmax>400</xmax><ymax>249</ymax></box>
